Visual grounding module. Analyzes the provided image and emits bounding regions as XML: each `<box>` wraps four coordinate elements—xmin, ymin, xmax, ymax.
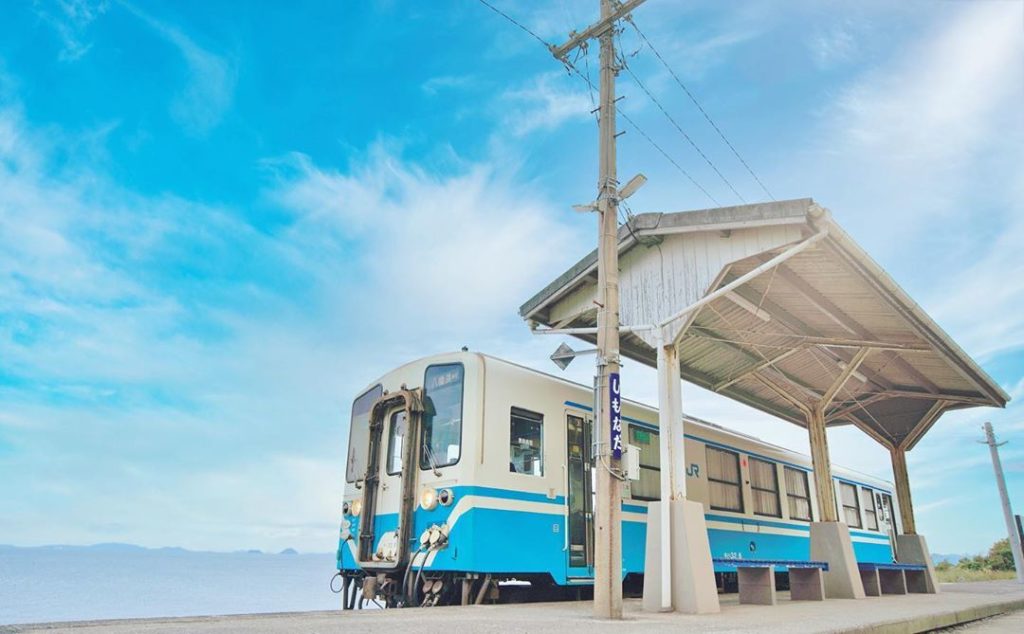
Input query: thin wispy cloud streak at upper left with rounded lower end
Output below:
<box><xmin>121</xmin><ymin>1</ymin><xmax>238</xmax><ymax>135</ymax></box>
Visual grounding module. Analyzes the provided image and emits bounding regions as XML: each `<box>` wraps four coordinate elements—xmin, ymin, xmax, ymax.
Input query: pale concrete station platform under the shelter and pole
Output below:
<box><xmin>8</xmin><ymin>581</ymin><xmax>1024</xmax><ymax>634</ymax></box>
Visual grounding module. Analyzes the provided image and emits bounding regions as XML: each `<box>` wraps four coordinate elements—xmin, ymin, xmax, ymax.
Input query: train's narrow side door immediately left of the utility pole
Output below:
<box><xmin>565</xmin><ymin>414</ymin><xmax>594</xmax><ymax>578</ymax></box>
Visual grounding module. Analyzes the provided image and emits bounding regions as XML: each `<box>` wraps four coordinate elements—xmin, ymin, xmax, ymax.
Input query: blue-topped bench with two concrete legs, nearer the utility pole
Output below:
<box><xmin>712</xmin><ymin>557</ymin><xmax>828</xmax><ymax>605</ymax></box>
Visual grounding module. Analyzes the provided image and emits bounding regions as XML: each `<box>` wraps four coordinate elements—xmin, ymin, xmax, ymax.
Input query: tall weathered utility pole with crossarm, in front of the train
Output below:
<box><xmin>551</xmin><ymin>0</ymin><xmax>644</xmax><ymax>619</ymax></box>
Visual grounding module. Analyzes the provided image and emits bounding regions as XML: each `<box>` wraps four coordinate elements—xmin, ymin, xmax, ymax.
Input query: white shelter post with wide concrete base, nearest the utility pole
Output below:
<box><xmin>643</xmin><ymin>345</ymin><xmax>720</xmax><ymax>614</ymax></box>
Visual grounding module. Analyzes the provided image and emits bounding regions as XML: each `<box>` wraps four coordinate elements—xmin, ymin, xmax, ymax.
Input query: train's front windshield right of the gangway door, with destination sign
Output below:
<box><xmin>420</xmin><ymin>364</ymin><xmax>465</xmax><ymax>469</ymax></box>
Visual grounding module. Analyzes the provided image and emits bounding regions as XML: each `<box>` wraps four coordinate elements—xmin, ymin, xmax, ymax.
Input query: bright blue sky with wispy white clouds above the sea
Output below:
<box><xmin>0</xmin><ymin>0</ymin><xmax>1024</xmax><ymax>553</ymax></box>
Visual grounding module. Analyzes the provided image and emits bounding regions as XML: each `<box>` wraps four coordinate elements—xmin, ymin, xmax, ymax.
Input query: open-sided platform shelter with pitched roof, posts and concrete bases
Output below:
<box><xmin>520</xmin><ymin>199</ymin><xmax>1009</xmax><ymax>612</ymax></box>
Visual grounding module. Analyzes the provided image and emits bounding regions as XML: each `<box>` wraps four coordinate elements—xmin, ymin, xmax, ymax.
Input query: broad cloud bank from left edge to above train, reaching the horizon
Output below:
<box><xmin>0</xmin><ymin>89</ymin><xmax>589</xmax><ymax>551</ymax></box>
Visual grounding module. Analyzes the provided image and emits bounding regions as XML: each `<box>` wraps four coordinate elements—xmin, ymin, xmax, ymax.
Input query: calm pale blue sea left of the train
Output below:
<box><xmin>0</xmin><ymin>545</ymin><xmax>341</xmax><ymax>625</ymax></box>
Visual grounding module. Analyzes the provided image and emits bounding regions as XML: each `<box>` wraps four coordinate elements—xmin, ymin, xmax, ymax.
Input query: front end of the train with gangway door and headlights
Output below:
<box><xmin>337</xmin><ymin>354</ymin><xmax>481</xmax><ymax>605</ymax></box>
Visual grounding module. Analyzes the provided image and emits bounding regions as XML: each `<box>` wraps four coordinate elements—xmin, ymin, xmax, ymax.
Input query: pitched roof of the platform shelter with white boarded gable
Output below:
<box><xmin>520</xmin><ymin>199</ymin><xmax>1009</xmax><ymax>449</ymax></box>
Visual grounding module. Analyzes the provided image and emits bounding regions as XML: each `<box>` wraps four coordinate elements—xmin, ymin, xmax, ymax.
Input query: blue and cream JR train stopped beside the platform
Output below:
<box><xmin>338</xmin><ymin>350</ymin><xmax>898</xmax><ymax>608</ymax></box>
